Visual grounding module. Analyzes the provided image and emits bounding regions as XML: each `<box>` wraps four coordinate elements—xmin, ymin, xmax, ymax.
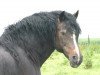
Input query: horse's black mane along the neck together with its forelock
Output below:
<box><xmin>3</xmin><ymin>11</ymin><xmax>81</xmax><ymax>39</ymax></box>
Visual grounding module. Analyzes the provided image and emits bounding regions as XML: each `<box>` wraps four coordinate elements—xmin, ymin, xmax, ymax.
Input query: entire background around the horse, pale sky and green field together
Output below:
<box><xmin>0</xmin><ymin>0</ymin><xmax>100</xmax><ymax>75</ymax></box>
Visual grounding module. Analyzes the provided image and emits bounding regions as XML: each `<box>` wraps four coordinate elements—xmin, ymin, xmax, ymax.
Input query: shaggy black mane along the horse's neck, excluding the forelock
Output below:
<box><xmin>1</xmin><ymin>12</ymin><xmax>57</xmax><ymax>48</ymax></box>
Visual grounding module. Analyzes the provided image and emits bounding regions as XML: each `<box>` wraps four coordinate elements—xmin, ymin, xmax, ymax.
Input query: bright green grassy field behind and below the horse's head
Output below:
<box><xmin>41</xmin><ymin>39</ymin><xmax>100</xmax><ymax>75</ymax></box>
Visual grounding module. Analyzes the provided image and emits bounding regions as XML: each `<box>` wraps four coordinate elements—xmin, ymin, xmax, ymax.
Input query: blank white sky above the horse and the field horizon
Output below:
<box><xmin>0</xmin><ymin>0</ymin><xmax>100</xmax><ymax>38</ymax></box>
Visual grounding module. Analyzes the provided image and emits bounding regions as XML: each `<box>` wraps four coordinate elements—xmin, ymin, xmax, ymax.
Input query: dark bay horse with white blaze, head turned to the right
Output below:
<box><xmin>0</xmin><ymin>11</ymin><xmax>82</xmax><ymax>75</ymax></box>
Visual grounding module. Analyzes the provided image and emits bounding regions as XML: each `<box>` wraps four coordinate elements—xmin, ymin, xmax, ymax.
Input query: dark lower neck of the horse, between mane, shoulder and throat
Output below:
<box><xmin>17</xmin><ymin>37</ymin><xmax>55</xmax><ymax>67</ymax></box>
